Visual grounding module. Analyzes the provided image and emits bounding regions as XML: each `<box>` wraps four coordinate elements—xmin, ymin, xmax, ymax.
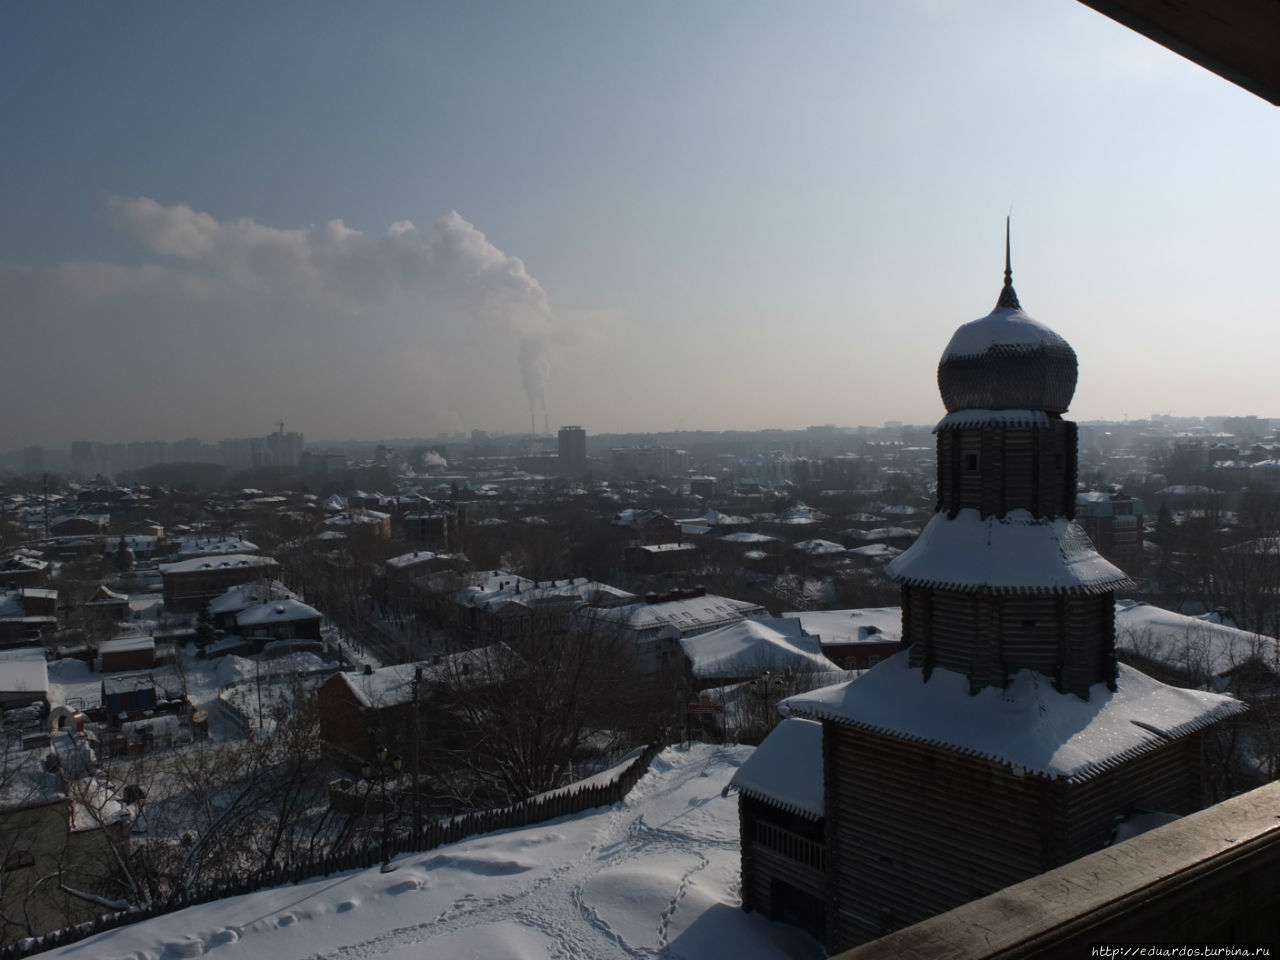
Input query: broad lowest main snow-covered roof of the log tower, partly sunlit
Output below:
<box><xmin>780</xmin><ymin>650</ymin><xmax>1245</xmax><ymax>781</ymax></box>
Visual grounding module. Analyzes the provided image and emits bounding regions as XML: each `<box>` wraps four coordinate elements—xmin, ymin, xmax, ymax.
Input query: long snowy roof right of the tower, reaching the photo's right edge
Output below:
<box><xmin>1116</xmin><ymin>600</ymin><xmax>1280</xmax><ymax>677</ymax></box>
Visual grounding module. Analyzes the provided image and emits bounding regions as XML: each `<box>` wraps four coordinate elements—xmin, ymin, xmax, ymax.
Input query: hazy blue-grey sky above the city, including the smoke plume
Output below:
<box><xmin>0</xmin><ymin>0</ymin><xmax>1280</xmax><ymax>449</ymax></box>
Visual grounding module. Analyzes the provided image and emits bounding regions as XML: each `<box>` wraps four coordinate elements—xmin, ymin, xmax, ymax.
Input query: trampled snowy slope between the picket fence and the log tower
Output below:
<box><xmin>44</xmin><ymin>744</ymin><xmax>824</xmax><ymax>960</ymax></box>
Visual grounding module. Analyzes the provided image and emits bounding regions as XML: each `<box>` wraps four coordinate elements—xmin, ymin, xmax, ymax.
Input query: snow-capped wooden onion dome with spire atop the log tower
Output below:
<box><xmin>938</xmin><ymin>220</ymin><xmax>1076</xmax><ymax>413</ymax></box>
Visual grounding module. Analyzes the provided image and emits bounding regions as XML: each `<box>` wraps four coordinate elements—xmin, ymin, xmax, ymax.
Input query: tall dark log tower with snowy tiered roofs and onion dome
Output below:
<box><xmin>733</xmin><ymin>225</ymin><xmax>1243</xmax><ymax>951</ymax></box>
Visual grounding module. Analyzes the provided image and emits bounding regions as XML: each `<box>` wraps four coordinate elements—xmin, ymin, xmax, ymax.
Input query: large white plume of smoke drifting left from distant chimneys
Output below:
<box><xmin>62</xmin><ymin>197</ymin><xmax>564</xmax><ymax>416</ymax></box>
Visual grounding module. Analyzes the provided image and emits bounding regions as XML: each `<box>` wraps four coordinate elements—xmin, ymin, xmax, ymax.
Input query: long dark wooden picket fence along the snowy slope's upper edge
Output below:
<box><xmin>0</xmin><ymin>744</ymin><xmax>662</xmax><ymax>960</ymax></box>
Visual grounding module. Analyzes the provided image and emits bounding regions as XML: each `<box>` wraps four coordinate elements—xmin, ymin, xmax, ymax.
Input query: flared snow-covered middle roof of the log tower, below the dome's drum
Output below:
<box><xmin>886</xmin><ymin>508</ymin><xmax>1130</xmax><ymax>594</ymax></box>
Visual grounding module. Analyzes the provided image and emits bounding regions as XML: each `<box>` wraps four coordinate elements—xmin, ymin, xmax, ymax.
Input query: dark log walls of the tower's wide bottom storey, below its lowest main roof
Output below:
<box><xmin>823</xmin><ymin>722</ymin><xmax>1202</xmax><ymax>951</ymax></box>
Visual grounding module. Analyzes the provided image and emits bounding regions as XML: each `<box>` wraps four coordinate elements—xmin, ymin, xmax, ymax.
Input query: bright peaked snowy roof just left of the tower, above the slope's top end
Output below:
<box><xmin>680</xmin><ymin>620</ymin><xmax>836</xmax><ymax>680</ymax></box>
